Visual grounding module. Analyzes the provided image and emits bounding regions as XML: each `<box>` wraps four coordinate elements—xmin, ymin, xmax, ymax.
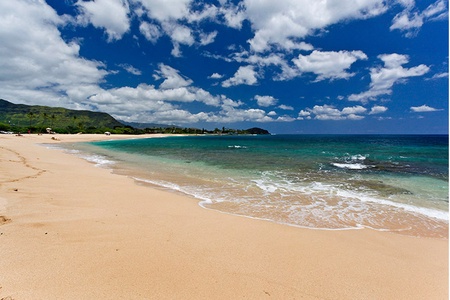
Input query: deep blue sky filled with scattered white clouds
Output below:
<box><xmin>0</xmin><ymin>0</ymin><xmax>449</xmax><ymax>134</ymax></box>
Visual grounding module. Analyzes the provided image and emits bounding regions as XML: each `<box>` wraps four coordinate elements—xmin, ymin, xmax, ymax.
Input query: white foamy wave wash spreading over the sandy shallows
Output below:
<box><xmin>123</xmin><ymin>172</ymin><xmax>448</xmax><ymax>237</ymax></box>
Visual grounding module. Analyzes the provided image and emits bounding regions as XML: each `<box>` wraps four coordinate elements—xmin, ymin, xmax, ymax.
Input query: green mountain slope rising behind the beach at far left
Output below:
<box><xmin>0</xmin><ymin>99</ymin><xmax>125</xmax><ymax>133</ymax></box>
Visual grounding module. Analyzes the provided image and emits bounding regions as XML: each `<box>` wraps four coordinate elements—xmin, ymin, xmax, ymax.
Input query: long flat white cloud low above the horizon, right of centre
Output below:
<box><xmin>299</xmin><ymin>105</ymin><xmax>367</xmax><ymax>121</ymax></box>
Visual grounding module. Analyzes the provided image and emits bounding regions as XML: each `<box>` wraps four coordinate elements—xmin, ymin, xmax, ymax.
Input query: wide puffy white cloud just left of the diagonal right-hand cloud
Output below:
<box><xmin>292</xmin><ymin>50</ymin><xmax>367</xmax><ymax>81</ymax></box>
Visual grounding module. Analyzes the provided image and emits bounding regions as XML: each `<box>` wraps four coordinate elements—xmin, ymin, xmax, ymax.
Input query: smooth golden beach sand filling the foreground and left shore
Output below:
<box><xmin>0</xmin><ymin>135</ymin><xmax>448</xmax><ymax>300</ymax></box>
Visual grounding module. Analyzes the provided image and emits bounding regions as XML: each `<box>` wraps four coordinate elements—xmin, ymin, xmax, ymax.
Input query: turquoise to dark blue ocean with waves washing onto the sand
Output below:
<box><xmin>60</xmin><ymin>135</ymin><xmax>449</xmax><ymax>238</ymax></box>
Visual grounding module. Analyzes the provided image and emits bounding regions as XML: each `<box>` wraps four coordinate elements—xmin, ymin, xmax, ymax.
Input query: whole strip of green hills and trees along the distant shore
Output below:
<box><xmin>0</xmin><ymin>99</ymin><xmax>269</xmax><ymax>135</ymax></box>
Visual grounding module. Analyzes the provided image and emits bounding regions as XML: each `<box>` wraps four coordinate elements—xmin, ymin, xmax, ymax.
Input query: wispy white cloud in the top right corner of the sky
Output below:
<box><xmin>390</xmin><ymin>0</ymin><xmax>448</xmax><ymax>37</ymax></box>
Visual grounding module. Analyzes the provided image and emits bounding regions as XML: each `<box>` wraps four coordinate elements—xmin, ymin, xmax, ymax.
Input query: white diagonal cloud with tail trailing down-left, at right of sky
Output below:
<box><xmin>348</xmin><ymin>53</ymin><xmax>430</xmax><ymax>103</ymax></box>
